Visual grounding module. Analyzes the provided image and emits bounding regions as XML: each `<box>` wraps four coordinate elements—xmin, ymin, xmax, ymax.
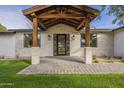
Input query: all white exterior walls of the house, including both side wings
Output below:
<box><xmin>0</xmin><ymin>24</ymin><xmax>119</xmax><ymax>57</ymax></box>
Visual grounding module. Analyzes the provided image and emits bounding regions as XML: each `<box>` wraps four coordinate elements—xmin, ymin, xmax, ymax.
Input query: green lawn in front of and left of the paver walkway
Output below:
<box><xmin>0</xmin><ymin>60</ymin><xmax>124</xmax><ymax>88</ymax></box>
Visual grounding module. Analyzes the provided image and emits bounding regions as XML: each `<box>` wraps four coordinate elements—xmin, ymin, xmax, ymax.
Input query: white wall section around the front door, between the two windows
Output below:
<box><xmin>41</xmin><ymin>24</ymin><xmax>81</xmax><ymax>56</ymax></box>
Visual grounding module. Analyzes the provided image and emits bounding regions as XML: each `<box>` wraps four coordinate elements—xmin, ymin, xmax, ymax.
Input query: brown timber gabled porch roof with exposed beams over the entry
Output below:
<box><xmin>23</xmin><ymin>5</ymin><xmax>99</xmax><ymax>30</ymax></box>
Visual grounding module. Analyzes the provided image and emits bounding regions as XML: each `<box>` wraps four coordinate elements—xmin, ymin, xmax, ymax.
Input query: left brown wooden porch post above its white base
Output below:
<box><xmin>33</xmin><ymin>17</ymin><xmax>38</xmax><ymax>47</ymax></box>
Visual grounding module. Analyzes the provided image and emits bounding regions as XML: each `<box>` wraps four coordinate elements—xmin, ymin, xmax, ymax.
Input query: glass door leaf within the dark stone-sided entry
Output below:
<box><xmin>57</xmin><ymin>35</ymin><xmax>66</xmax><ymax>55</ymax></box>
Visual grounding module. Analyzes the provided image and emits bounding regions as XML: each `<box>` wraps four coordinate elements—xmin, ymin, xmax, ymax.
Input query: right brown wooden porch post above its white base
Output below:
<box><xmin>85</xmin><ymin>19</ymin><xmax>90</xmax><ymax>47</ymax></box>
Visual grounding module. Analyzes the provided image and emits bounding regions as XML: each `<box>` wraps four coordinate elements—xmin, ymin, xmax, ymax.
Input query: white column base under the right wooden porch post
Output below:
<box><xmin>84</xmin><ymin>47</ymin><xmax>92</xmax><ymax>64</ymax></box>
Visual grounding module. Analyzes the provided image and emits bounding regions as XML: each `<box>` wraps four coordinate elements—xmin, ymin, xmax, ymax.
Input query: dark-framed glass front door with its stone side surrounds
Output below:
<box><xmin>53</xmin><ymin>34</ymin><xmax>70</xmax><ymax>56</ymax></box>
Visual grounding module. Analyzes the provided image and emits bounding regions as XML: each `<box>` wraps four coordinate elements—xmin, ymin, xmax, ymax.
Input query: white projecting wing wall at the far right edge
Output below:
<box><xmin>114</xmin><ymin>29</ymin><xmax>124</xmax><ymax>56</ymax></box>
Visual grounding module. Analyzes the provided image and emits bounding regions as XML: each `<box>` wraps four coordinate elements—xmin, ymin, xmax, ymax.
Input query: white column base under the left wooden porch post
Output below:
<box><xmin>31</xmin><ymin>47</ymin><xmax>40</xmax><ymax>64</ymax></box>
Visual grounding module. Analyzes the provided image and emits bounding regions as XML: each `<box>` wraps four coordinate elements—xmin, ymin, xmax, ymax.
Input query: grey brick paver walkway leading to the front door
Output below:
<box><xmin>18</xmin><ymin>57</ymin><xmax>124</xmax><ymax>74</ymax></box>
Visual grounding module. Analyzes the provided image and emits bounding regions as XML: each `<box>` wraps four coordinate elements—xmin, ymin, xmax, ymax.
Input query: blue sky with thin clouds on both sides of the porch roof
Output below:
<box><xmin>0</xmin><ymin>5</ymin><xmax>119</xmax><ymax>29</ymax></box>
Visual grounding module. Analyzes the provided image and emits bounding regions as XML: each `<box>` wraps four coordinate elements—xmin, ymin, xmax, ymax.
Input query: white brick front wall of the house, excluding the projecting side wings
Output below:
<box><xmin>16</xmin><ymin>24</ymin><xmax>114</xmax><ymax>57</ymax></box>
